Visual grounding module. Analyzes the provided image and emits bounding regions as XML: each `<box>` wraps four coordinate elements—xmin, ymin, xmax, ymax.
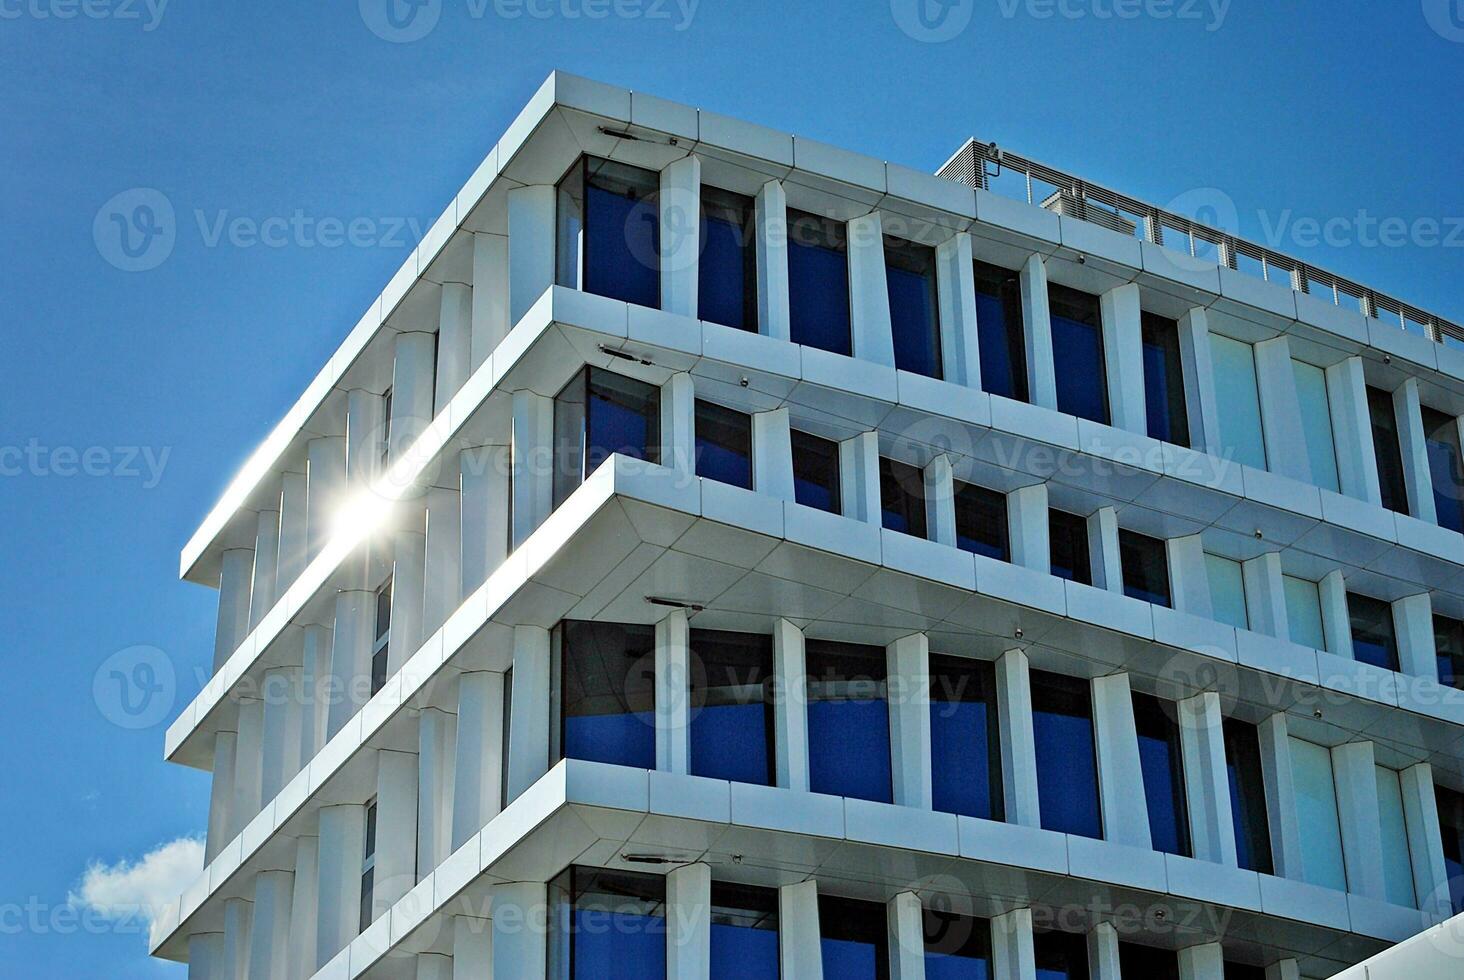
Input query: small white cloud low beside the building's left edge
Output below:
<box><xmin>67</xmin><ymin>836</ymin><xmax>203</xmax><ymax>924</ymax></box>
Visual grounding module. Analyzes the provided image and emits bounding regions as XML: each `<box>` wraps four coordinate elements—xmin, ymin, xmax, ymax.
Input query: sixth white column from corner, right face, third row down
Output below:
<box><xmin>1177</xmin><ymin>691</ymin><xmax>1239</xmax><ymax>867</ymax></box>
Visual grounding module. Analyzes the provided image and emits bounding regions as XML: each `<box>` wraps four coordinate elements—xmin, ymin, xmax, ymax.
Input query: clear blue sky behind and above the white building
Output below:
<box><xmin>0</xmin><ymin>0</ymin><xmax>1464</xmax><ymax>980</ymax></box>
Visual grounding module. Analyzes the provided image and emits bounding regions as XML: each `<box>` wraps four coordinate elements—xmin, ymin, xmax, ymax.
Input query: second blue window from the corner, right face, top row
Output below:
<box><xmin>697</xmin><ymin>185</ymin><xmax>757</xmax><ymax>333</ymax></box>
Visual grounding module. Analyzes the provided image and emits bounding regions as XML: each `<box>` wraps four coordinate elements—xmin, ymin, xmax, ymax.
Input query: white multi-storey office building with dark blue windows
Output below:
<box><xmin>154</xmin><ymin>75</ymin><xmax>1464</xmax><ymax>980</ymax></box>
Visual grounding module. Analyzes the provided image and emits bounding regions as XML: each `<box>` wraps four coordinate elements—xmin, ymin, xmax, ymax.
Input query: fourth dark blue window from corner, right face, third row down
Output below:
<box><xmin>930</xmin><ymin>655</ymin><xmax>1004</xmax><ymax>820</ymax></box>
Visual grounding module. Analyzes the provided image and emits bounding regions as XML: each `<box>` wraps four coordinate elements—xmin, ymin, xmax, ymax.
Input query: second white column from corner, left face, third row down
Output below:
<box><xmin>448</xmin><ymin>671</ymin><xmax>504</xmax><ymax>853</ymax></box>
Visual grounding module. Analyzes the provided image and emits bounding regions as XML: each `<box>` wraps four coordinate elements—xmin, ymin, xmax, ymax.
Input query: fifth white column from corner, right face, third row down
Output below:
<box><xmin>1092</xmin><ymin>674</ymin><xmax>1154</xmax><ymax>850</ymax></box>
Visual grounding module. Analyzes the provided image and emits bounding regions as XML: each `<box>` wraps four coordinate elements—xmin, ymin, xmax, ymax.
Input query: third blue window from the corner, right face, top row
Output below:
<box><xmin>788</xmin><ymin>208</ymin><xmax>854</xmax><ymax>354</ymax></box>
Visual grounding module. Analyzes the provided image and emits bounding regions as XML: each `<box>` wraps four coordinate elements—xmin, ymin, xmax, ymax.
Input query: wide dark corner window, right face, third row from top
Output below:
<box><xmin>553</xmin><ymin>621</ymin><xmax>656</xmax><ymax>769</ymax></box>
